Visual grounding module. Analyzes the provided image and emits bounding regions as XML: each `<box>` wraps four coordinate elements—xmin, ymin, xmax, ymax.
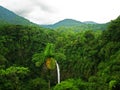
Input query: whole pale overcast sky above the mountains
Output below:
<box><xmin>0</xmin><ymin>0</ymin><xmax>120</xmax><ymax>24</ymax></box>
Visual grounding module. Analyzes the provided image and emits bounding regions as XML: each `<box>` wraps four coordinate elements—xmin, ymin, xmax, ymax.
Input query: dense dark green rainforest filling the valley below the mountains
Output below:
<box><xmin>0</xmin><ymin>16</ymin><xmax>120</xmax><ymax>90</ymax></box>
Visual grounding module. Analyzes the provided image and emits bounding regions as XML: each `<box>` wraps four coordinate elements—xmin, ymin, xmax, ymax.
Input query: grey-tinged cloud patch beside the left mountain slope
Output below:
<box><xmin>14</xmin><ymin>0</ymin><xmax>55</xmax><ymax>17</ymax></box>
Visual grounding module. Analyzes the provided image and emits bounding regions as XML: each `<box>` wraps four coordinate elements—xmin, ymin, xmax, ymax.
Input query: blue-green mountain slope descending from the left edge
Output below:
<box><xmin>0</xmin><ymin>6</ymin><xmax>33</xmax><ymax>25</ymax></box>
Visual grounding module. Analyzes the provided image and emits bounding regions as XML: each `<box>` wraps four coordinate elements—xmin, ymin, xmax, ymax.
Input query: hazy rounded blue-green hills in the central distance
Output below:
<box><xmin>41</xmin><ymin>19</ymin><xmax>107</xmax><ymax>32</ymax></box>
